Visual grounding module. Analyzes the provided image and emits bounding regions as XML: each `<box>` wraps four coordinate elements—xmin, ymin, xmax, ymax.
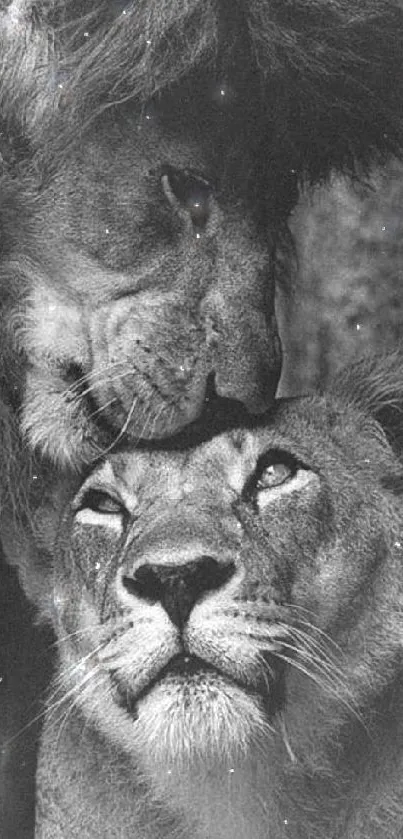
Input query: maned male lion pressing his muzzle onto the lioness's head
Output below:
<box><xmin>0</xmin><ymin>0</ymin><xmax>403</xmax><ymax>473</ymax></box>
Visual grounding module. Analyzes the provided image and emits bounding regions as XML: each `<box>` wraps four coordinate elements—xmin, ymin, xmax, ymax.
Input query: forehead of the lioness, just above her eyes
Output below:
<box><xmin>83</xmin><ymin>395</ymin><xmax>366</xmax><ymax>500</ymax></box>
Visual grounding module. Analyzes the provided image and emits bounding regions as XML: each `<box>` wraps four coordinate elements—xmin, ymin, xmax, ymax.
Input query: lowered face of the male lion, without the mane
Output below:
<box><xmin>3</xmin><ymin>103</ymin><xmax>280</xmax><ymax>464</ymax></box>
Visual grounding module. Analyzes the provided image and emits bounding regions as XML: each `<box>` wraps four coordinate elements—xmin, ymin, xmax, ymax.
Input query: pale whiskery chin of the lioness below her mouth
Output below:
<box><xmin>135</xmin><ymin>671</ymin><xmax>271</xmax><ymax>777</ymax></box>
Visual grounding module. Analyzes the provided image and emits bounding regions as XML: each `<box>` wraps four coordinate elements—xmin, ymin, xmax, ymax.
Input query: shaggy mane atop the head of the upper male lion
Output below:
<box><xmin>0</xmin><ymin>0</ymin><xmax>403</xmax><ymax>182</ymax></box>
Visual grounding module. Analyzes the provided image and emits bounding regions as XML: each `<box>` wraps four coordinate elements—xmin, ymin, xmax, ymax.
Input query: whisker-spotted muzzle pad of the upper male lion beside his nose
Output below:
<box><xmin>89</xmin><ymin>291</ymin><xmax>208</xmax><ymax>430</ymax></box>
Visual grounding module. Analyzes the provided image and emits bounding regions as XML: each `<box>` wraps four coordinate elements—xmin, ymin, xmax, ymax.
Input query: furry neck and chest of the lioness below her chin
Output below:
<box><xmin>35</xmin><ymin>700</ymin><xmax>403</xmax><ymax>839</ymax></box>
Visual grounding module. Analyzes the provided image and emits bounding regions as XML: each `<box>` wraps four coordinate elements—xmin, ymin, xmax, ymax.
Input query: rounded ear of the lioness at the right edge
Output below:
<box><xmin>331</xmin><ymin>349</ymin><xmax>403</xmax><ymax>455</ymax></box>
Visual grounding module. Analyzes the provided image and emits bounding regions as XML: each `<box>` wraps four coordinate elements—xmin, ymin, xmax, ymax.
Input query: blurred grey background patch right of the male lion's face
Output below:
<box><xmin>278</xmin><ymin>162</ymin><xmax>403</xmax><ymax>394</ymax></box>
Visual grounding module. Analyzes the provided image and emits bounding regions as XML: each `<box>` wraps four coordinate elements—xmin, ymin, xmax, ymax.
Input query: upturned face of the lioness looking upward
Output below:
<box><xmin>26</xmin><ymin>397</ymin><xmax>401</xmax><ymax>775</ymax></box>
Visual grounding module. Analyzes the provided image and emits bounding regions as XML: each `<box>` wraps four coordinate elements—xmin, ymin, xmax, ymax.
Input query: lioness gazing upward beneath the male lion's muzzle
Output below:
<box><xmin>4</xmin><ymin>356</ymin><xmax>403</xmax><ymax>839</ymax></box>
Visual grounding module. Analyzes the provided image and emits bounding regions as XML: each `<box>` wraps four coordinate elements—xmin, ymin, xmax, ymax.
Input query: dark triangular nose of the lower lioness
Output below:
<box><xmin>123</xmin><ymin>556</ymin><xmax>235</xmax><ymax>629</ymax></box>
